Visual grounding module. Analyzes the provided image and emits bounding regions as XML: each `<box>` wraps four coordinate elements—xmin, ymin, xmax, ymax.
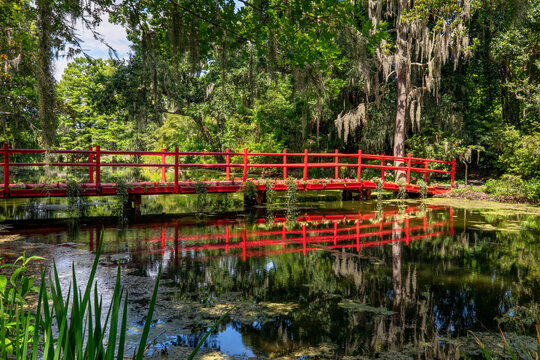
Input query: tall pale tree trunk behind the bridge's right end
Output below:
<box><xmin>394</xmin><ymin>0</ymin><xmax>409</xmax><ymax>181</ymax></box>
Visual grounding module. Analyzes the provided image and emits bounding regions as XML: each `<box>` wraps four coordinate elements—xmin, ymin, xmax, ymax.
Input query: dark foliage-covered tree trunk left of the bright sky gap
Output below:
<box><xmin>36</xmin><ymin>0</ymin><xmax>57</xmax><ymax>149</ymax></box>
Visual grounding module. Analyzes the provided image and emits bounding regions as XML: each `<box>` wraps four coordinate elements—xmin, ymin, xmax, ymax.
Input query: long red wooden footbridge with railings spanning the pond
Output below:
<box><xmin>0</xmin><ymin>144</ymin><xmax>456</xmax><ymax>198</ymax></box>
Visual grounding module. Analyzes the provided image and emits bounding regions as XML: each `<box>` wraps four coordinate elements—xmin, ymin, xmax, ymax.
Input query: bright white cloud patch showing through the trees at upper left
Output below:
<box><xmin>54</xmin><ymin>15</ymin><xmax>131</xmax><ymax>80</ymax></box>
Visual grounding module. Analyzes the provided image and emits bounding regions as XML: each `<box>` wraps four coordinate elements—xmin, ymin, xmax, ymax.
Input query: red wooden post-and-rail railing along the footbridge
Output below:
<box><xmin>0</xmin><ymin>143</ymin><xmax>456</xmax><ymax>193</ymax></box>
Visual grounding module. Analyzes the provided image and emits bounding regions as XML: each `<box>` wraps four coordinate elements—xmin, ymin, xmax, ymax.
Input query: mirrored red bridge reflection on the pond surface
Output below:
<box><xmin>81</xmin><ymin>205</ymin><xmax>454</xmax><ymax>263</ymax></box>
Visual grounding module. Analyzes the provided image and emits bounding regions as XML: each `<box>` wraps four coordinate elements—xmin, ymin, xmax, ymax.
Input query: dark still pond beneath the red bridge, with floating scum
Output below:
<box><xmin>0</xmin><ymin>195</ymin><xmax>540</xmax><ymax>359</ymax></box>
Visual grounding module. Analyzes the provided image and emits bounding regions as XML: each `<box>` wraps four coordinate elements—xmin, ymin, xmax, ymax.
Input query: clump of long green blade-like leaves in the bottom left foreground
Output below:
<box><xmin>0</xmin><ymin>232</ymin><xmax>161</xmax><ymax>360</ymax></box>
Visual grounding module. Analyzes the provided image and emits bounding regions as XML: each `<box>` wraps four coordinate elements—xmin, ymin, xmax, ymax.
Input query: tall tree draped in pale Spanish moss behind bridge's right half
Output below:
<box><xmin>336</xmin><ymin>0</ymin><xmax>471</xmax><ymax>174</ymax></box>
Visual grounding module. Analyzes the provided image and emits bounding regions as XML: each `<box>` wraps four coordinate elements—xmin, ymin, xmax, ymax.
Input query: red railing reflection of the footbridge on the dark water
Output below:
<box><xmin>86</xmin><ymin>206</ymin><xmax>454</xmax><ymax>260</ymax></box>
